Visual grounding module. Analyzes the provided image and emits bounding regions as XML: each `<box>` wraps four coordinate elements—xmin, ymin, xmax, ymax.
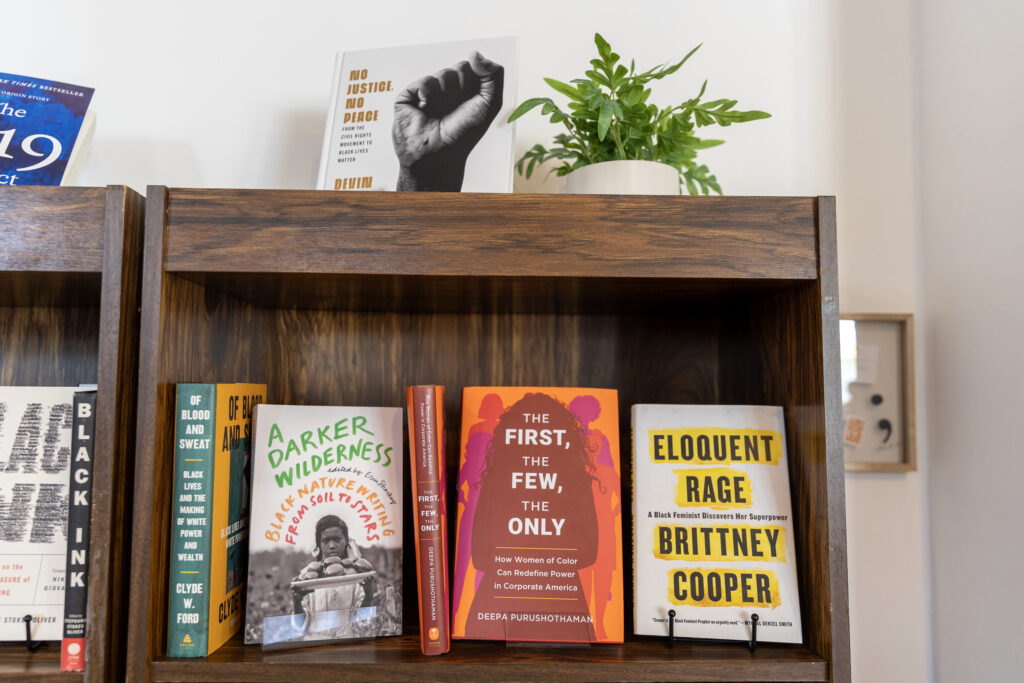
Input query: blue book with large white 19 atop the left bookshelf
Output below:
<box><xmin>0</xmin><ymin>74</ymin><xmax>94</xmax><ymax>185</ymax></box>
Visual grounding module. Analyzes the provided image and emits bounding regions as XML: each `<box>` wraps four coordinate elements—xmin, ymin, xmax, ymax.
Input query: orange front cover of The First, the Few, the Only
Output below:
<box><xmin>452</xmin><ymin>387</ymin><xmax>623</xmax><ymax>643</ymax></box>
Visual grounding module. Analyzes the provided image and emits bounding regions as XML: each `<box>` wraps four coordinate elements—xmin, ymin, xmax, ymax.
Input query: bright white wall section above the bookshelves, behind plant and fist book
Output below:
<box><xmin>2</xmin><ymin>0</ymin><xmax>836</xmax><ymax>194</ymax></box>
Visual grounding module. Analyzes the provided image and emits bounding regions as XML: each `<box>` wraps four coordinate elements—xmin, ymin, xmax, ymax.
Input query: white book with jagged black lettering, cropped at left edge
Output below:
<box><xmin>0</xmin><ymin>386</ymin><xmax>77</xmax><ymax>642</ymax></box>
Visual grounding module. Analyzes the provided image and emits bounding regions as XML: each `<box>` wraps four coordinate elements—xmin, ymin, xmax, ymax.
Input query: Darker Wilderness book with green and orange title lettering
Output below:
<box><xmin>245</xmin><ymin>404</ymin><xmax>404</xmax><ymax>647</ymax></box>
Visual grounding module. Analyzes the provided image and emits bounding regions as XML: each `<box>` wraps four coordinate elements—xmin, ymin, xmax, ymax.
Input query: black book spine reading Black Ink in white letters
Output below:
<box><xmin>60</xmin><ymin>391</ymin><xmax>96</xmax><ymax>671</ymax></box>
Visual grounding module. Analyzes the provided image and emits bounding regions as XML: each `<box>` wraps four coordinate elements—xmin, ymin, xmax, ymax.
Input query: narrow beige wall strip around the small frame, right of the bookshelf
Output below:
<box><xmin>834</xmin><ymin>0</ymin><xmax>932</xmax><ymax>682</ymax></box>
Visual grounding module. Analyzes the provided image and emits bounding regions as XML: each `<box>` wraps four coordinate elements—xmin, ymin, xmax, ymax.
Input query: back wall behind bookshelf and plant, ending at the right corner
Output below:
<box><xmin>6</xmin><ymin>0</ymin><xmax>931</xmax><ymax>681</ymax></box>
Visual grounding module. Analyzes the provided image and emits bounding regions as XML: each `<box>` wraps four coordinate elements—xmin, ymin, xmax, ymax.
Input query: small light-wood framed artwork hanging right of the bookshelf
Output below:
<box><xmin>840</xmin><ymin>313</ymin><xmax>918</xmax><ymax>472</ymax></box>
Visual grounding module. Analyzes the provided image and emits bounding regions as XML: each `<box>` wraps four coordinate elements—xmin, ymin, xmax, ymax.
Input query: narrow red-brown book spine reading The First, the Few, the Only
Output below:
<box><xmin>407</xmin><ymin>385</ymin><xmax>451</xmax><ymax>654</ymax></box>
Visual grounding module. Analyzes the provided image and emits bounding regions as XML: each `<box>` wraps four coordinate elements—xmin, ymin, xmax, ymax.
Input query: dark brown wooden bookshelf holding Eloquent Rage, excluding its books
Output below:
<box><xmin>127</xmin><ymin>187</ymin><xmax>850</xmax><ymax>681</ymax></box>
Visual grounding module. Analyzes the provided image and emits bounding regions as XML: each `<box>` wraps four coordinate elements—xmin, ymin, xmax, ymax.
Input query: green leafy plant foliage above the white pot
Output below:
<box><xmin>509</xmin><ymin>34</ymin><xmax>771</xmax><ymax>195</ymax></box>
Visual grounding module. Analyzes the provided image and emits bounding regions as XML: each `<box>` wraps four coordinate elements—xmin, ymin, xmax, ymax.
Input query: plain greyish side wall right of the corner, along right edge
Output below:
<box><xmin>921</xmin><ymin>0</ymin><xmax>1024</xmax><ymax>682</ymax></box>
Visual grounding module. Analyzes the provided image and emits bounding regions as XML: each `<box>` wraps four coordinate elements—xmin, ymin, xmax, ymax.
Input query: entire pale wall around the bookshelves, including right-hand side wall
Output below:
<box><xmin>16</xmin><ymin>0</ymin><xmax>1024</xmax><ymax>681</ymax></box>
